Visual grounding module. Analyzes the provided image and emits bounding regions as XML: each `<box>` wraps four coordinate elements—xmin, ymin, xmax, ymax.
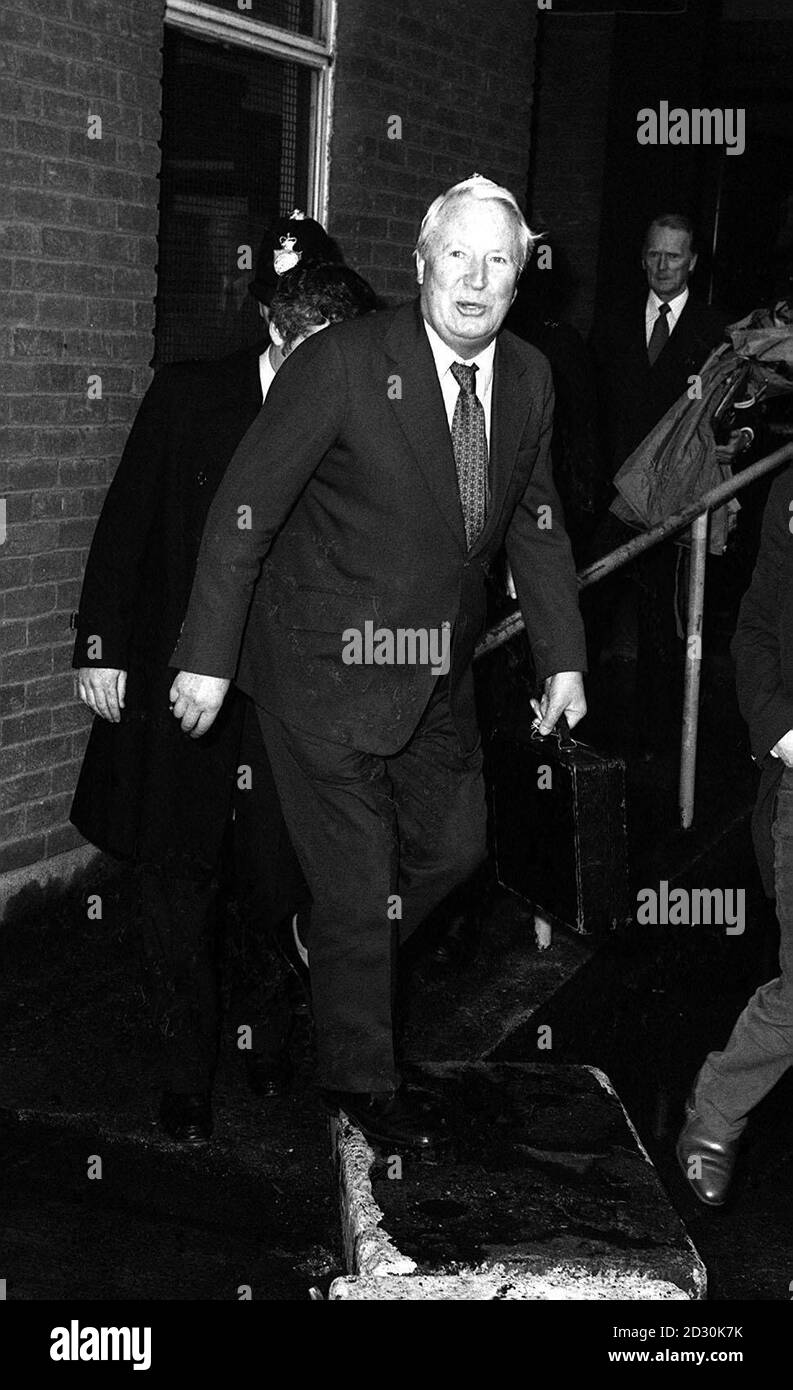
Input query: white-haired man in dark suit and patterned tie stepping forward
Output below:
<box><xmin>171</xmin><ymin>175</ymin><xmax>586</xmax><ymax>1147</ymax></box>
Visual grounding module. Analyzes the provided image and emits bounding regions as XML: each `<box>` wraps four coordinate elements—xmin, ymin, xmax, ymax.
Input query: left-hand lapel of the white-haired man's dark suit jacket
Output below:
<box><xmin>383</xmin><ymin>300</ymin><xmax>465</xmax><ymax>549</ymax></box>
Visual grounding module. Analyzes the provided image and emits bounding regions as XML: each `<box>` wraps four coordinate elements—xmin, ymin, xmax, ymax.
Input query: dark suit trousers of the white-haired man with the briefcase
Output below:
<box><xmin>258</xmin><ymin>677</ymin><xmax>486</xmax><ymax>1091</ymax></box>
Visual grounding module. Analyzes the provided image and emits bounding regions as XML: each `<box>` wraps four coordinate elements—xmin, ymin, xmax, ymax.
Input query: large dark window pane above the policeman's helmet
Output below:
<box><xmin>154</xmin><ymin>28</ymin><xmax>312</xmax><ymax>366</ymax></box>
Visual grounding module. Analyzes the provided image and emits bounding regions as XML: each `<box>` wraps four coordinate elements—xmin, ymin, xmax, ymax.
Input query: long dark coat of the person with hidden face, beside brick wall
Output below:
<box><xmin>71</xmin><ymin>346</ymin><xmax>261</xmax><ymax>877</ymax></box>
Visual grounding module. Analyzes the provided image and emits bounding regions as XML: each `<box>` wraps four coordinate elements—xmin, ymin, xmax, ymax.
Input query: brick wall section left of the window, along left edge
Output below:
<box><xmin>0</xmin><ymin>0</ymin><xmax>162</xmax><ymax>872</ymax></box>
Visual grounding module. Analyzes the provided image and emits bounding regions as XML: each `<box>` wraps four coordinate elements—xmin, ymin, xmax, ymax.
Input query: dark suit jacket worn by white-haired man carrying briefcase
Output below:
<box><xmin>172</xmin><ymin>302</ymin><xmax>585</xmax><ymax>756</ymax></box>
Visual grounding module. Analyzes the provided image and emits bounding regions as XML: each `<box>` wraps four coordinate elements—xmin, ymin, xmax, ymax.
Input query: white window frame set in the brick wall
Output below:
<box><xmin>165</xmin><ymin>0</ymin><xmax>336</xmax><ymax>227</ymax></box>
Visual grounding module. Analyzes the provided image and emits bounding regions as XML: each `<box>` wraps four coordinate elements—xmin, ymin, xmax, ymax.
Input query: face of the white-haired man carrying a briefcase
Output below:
<box><xmin>417</xmin><ymin>197</ymin><xmax>521</xmax><ymax>359</ymax></box>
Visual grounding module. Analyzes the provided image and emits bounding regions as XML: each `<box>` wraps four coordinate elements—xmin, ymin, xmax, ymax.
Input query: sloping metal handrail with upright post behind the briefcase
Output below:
<box><xmin>474</xmin><ymin>443</ymin><xmax>793</xmax><ymax>830</ymax></box>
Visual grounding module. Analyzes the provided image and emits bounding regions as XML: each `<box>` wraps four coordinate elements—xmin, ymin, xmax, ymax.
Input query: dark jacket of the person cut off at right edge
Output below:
<box><xmin>732</xmin><ymin>468</ymin><xmax>793</xmax><ymax>897</ymax></box>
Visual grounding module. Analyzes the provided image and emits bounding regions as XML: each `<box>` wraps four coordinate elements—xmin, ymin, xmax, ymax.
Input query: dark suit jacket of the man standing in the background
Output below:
<box><xmin>590</xmin><ymin>295</ymin><xmax>729</xmax><ymax>477</ymax></box>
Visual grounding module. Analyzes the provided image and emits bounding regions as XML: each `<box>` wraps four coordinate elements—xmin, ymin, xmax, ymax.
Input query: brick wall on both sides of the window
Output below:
<box><xmin>0</xmin><ymin>0</ymin><xmax>536</xmax><ymax>873</ymax></box>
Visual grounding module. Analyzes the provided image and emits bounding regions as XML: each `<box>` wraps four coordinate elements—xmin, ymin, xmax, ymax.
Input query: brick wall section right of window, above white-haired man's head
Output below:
<box><xmin>329</xmin><ymin>0</ymin><xmax>537</xmax><ymax>302</ymax></box>
